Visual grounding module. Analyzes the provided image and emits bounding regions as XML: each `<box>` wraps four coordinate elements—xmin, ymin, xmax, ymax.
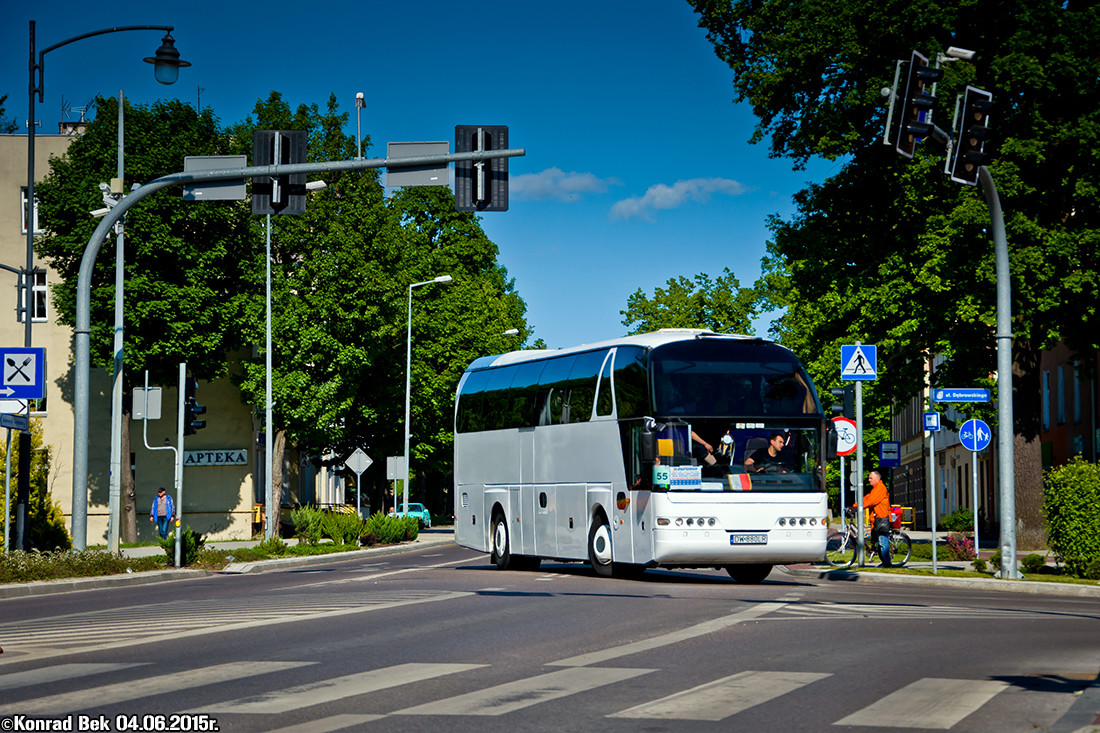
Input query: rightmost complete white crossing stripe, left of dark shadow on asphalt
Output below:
<box><xmin>834</xmin><ymin>677</ymin><xmax>1009</xmax><ymax>731</ymax></box>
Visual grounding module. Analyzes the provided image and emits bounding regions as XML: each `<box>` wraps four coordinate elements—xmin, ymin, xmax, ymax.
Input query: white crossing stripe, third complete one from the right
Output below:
<box><xmin>391</xmin><ymin>667</ymin><xmax>657</xmax><ymax>715</ymax></box>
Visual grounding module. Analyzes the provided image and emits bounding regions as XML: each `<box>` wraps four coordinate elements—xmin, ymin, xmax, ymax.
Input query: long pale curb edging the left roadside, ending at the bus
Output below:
<box><xmin>0</xmin><ymin>534</ymin><xmax>454</xmax><ymax>600</ymax></box>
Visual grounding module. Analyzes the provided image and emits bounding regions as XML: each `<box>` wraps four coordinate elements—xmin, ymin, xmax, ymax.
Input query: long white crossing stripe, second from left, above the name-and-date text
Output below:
<box><xmin>0</xmin><ymin>661</ymin><xmax>317</xmax><ymax>715</ymax></box>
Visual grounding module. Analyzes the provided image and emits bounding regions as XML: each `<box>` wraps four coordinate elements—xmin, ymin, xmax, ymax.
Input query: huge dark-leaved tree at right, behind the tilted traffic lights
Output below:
<box><xmin>691</xmin><ymin>0</ymin><xmax>1100</xmax><ymax>546</ymax></box>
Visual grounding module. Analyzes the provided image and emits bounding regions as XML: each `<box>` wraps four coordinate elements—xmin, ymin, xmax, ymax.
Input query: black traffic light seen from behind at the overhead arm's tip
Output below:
<box><xmin>454</xmin><ymin>124</ymin><xmax>508</xmax><ymax>211</ymax></box>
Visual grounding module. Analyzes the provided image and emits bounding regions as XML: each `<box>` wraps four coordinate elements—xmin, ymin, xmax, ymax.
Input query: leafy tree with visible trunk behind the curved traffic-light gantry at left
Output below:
<box><xmin>35</xmin><ymin>99</ymin><xmax>255</xmax><ymax>541</ymax></box>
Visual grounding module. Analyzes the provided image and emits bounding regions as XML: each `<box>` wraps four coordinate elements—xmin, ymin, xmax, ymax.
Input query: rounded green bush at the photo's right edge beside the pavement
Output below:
<box><xmin>1043</xmin><ymin>457</ymin><xmax>1100</xmax><ymax>578</ymax></box>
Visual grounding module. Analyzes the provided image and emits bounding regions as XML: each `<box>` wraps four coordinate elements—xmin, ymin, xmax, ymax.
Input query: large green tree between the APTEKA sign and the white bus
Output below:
<box><xmin>226</xmin><ymin>92</ymin><xmax>526</xmax><ymax>512</ymax></box>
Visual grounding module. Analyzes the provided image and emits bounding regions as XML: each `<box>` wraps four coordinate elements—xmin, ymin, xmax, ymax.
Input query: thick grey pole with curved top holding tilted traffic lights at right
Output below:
<box><xmin>978</xmin><ymin>165</ymin><xmax>1020</xmax><ymax>579</ymax></box>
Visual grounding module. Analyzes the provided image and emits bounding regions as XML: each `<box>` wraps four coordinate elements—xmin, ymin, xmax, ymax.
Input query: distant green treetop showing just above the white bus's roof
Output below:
<box><xmin>619</xmin><ymin>267</ymin><xmax>757</xmax><ymax>333</ymax></box>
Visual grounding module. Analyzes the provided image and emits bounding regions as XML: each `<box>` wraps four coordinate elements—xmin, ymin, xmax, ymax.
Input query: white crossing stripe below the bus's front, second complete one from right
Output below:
<box><xmin>608</xmin><ymin>670</ymin><xmax>829</xmax><ymax>721</ymax></box>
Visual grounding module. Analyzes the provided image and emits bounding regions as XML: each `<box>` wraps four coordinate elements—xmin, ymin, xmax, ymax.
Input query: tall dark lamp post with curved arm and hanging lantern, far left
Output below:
<box><xmin>26</xmin><ymin>21</ymin><xmax>190</xmax><ymax>549</ymax></box>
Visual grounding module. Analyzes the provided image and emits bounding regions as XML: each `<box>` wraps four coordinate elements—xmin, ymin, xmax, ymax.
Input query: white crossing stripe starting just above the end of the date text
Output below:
<box><xmin>187</xmin><ymin>663</ymin><xmax>485</xmax><ymax>708</ymax></box>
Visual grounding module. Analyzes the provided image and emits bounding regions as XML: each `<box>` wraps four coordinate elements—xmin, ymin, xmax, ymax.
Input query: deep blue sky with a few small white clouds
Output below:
<box><xmin>0</xmin><ymin>0</ymin><xmax>828</xmax><ymax>347</ymax></box>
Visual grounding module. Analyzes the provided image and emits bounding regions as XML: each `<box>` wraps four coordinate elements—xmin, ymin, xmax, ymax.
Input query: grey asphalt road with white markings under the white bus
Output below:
<box><xmin>0</xmin><ymin>545</ymin><xmax>1100</xmax><ymax>733</ymax></box>
